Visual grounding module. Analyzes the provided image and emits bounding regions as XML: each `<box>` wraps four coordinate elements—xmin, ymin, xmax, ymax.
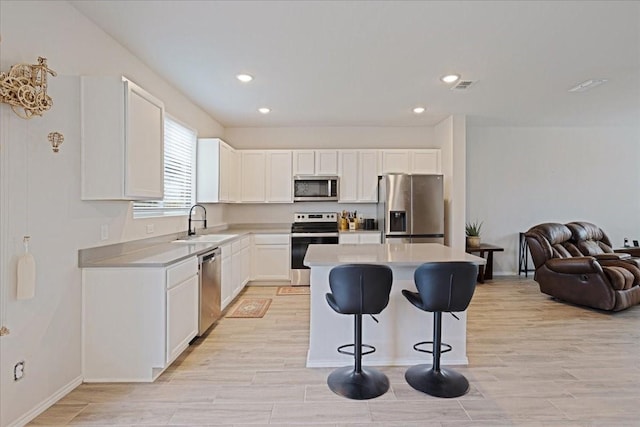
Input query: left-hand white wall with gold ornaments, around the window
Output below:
<box><xmin>0</xmin><ymin>0</ymin><xmax>223</xmax><ymax>426</ymax></box>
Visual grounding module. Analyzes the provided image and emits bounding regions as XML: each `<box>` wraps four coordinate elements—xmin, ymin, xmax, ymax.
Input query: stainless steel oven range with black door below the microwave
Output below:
<box><xmin>291</xmin><ymin>212</ymin><xmax>338</xmax><ymax>286</ymax></box>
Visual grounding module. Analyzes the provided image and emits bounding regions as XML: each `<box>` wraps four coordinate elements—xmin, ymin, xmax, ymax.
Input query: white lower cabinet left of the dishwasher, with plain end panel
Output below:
<box><xmin>82</xmin><ymin>256</ymin><xmax>199</xmax><ymax>382</ymax></box>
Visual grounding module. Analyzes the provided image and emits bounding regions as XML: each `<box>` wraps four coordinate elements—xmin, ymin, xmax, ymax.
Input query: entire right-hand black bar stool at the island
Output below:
<box><xmin>402</xmin><ymin>262</ymin><xmax>478</xmax><ymax>397</ymax></box>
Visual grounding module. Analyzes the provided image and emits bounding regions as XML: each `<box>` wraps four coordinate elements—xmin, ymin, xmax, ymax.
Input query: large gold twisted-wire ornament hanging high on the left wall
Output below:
<box><xmin>0</xmin><ymin>57</ymin><xmax>56</xmax><ymax>119</ymax></box>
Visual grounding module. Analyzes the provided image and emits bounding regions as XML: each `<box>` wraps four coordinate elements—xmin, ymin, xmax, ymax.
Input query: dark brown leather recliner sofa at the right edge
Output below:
<box><xmin>525</xmin><ymin>222</ymin><xmax>640</xmax><ymax>311</ymax></box>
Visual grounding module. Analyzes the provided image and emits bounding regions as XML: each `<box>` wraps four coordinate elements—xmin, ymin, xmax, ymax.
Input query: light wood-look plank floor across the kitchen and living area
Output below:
<box><xmin>32</xmin><ymin>277</ymin><xmax>640</xmax><ymax>427</ymax></box>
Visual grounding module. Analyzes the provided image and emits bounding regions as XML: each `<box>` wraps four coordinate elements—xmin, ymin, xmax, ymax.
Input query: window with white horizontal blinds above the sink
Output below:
<box><xmin>133</xmin><ymin>115</ymin><xmax>197</xmax><ymax>218</ymax></box>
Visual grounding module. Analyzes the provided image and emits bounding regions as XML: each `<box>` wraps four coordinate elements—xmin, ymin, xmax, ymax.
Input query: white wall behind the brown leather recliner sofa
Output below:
<box><xmin>466</xmin><ymin>127</ymin><xmax>640</xmax><ymax>274</ymax></box>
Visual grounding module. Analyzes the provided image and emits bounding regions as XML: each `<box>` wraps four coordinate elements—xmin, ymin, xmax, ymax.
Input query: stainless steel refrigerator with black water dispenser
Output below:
<box><xmin>377</xmin><ymin>174</ymin><xmax>444</xmax><ymax>243</ymax></box>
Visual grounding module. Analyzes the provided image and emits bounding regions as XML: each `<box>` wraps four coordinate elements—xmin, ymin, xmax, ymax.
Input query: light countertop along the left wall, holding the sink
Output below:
<box><xmin>78</xmin><ymin>224</ymin><xmax>291</xmax><ymax>268</ymax></box>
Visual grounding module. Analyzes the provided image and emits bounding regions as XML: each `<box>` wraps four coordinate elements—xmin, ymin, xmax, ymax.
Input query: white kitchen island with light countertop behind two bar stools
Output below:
<box><xmin>304</xmin><ymin>243</ymin><xmax>486</xmax><ymax>367</ymax></box>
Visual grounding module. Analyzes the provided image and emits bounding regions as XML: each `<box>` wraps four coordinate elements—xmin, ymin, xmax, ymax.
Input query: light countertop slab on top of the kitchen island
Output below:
<box><xmin>304</xmin><ymin>243</ymin><xmax>486</xmax><ymax>267</ymax></box>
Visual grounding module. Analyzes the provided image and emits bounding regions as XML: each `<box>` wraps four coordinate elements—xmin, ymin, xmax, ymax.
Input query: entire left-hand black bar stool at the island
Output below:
<box><xmin>326</xmin><ymin>264</ymin><xmax>393</xmax><ymax>400</ymax></box>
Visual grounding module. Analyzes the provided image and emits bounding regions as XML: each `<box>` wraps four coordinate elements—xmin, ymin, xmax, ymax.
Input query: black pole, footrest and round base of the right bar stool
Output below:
<box><xmin>404</xmin><ymin>311</ymin><xmax>469</xmax><ymax>397</ymax></box>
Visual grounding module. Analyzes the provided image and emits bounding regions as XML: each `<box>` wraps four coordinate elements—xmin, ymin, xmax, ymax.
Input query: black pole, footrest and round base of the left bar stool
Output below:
<box><xmin>327</xmin><ymin>314</ymin><xmax>389</xmax><ymax>400</ymax></box>
